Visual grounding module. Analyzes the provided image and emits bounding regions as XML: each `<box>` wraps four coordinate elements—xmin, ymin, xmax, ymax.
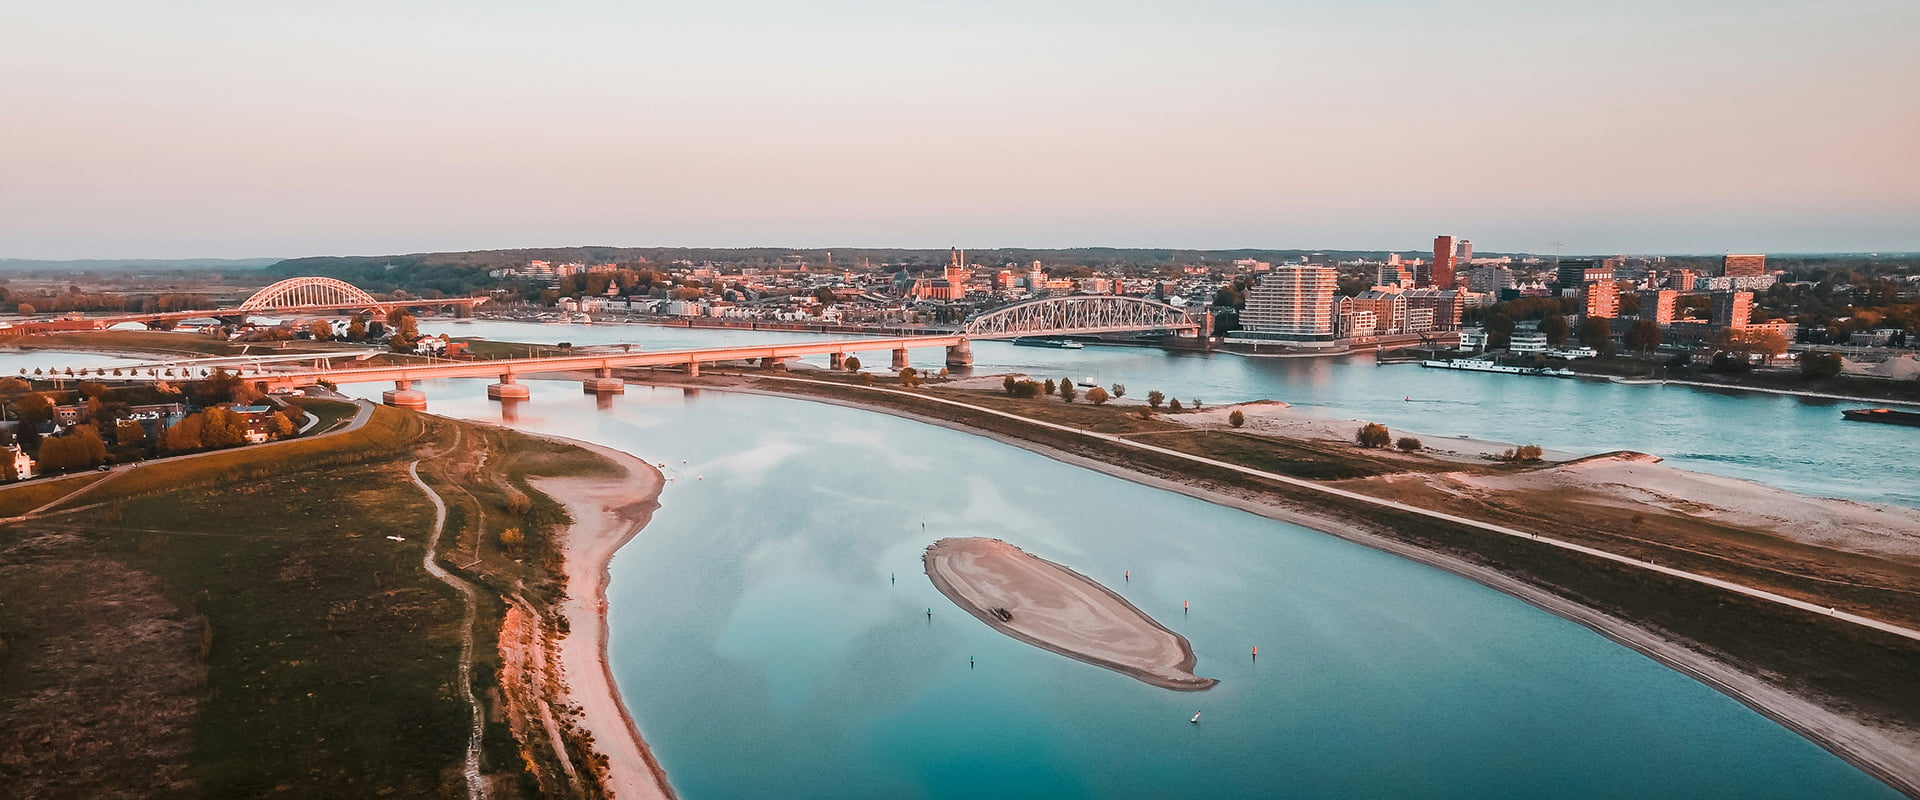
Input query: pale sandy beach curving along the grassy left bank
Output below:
<box><xmin>530</xmin><ymin>437</ymin><xmax>676</xmax><ymax>800</ymax></box>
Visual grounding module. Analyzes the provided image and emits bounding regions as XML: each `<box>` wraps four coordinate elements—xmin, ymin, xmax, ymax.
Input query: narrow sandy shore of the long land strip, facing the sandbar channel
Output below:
<box><xmin>633</xmin><ymin>380</ymin><xmax>1920</xmax><ymax>798</ymax></box>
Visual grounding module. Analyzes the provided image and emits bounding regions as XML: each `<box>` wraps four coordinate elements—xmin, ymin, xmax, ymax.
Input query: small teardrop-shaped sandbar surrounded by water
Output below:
<box><xmin>922</xmin><ymin>537</ymin><xmax>1219</xmax><ymax>693</ymax></box>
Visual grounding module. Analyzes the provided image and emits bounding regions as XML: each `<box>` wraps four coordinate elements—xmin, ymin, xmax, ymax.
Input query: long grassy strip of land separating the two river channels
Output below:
<box><xmin>628</xmin><ymin>368</ymin><xmax>1920</xmax><ymax>798</ymax></box>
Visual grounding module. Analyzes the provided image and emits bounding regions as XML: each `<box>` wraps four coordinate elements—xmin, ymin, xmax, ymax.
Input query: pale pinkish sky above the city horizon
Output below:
<box><xmin>0</xmin><ymin>0</ymin><xmax>1920</xmax><ymax>259</ymax></box>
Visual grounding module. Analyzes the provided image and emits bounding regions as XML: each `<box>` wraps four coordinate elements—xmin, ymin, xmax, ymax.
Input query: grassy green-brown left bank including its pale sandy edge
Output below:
<box><xmin>0</xmin><ymin>401</ymin><xmax>672</xmax><ymax>798</ymax></box>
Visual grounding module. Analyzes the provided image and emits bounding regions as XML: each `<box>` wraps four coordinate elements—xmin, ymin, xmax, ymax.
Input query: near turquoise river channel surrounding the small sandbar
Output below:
<box><xmin>355</xmin><ymin>380</ymin><xmax>1895</xmax><ymax>800</ymax></box>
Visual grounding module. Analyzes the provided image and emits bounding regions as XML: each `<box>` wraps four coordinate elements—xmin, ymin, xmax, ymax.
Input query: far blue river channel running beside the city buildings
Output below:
<box><xmin>424</xmin><ymin>320</ymin><xmax>1920</xmax><ymax>506</ymax></box>
